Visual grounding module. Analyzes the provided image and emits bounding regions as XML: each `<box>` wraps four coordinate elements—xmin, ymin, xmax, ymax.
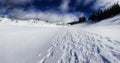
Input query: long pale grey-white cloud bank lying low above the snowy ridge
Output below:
<box><xmin>9</xmin><ymin>9</ymin><xmax>78</xmax><ymax>22</ymax></box>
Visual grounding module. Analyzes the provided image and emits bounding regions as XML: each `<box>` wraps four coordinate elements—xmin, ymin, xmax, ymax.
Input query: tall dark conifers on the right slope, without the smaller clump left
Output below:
<box><xmin>88</xmin><ymin>3</ymin><xmax>120</xmax><ymax>22</ymax></box>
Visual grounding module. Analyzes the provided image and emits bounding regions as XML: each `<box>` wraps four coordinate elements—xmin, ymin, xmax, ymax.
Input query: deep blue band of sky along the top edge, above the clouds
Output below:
<box><xmin>0</xmin><ymin>0</ymin><xmax>96</xmax><ymax>12</ymax></box>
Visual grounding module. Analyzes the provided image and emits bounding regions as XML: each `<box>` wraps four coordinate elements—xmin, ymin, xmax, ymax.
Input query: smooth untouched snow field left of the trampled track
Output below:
<box><xmin>0</xmin><ymin>24</ymin><xmax>62</xmax><ymax>63</ymax></box>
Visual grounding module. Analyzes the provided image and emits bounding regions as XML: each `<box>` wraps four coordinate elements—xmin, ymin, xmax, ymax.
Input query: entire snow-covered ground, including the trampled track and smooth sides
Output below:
<box><xmin>0</xmin><ymin>15</ymin><xmax>120</xmax><ymax>63</ymax></box>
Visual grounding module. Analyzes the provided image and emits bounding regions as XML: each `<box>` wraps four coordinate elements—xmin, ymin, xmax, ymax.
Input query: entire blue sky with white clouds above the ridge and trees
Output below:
<box><xmin>0</xmin><ymin>0</ymin><xmax>119</xmax><ymax>21</ymax></box>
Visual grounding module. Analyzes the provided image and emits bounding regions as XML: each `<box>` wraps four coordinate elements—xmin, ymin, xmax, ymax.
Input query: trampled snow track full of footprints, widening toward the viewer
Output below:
<box><xmin>38</xmin><ymin>28</ymin><xmax>120</xmax><ymax>63</ymax></box>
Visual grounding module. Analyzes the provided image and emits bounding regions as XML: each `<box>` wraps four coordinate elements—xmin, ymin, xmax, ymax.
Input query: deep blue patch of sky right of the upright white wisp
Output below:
<box><xmin>69</xmin><ymin>0</ymin><xmax>97</xmax><ymax>14</ymax></box>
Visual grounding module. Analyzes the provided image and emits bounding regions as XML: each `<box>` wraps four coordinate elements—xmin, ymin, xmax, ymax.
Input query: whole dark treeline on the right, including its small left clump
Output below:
<box><xmin>68</xmin><ymin>3</ymin><xmax>120</xmax><ymax>25</ymax></box>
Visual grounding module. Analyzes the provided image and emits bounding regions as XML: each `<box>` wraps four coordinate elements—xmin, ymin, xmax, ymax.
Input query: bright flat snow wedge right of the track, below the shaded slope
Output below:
<box><xmin>79</xmin><ymin>25</ymin><xmax>120</xmax><ymax>41</ymax></box>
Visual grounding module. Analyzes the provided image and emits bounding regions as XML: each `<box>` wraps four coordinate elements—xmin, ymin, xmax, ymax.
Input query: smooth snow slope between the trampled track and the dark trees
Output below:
<box><xmin>72</xmin><ymin>15</ymin><xmax>120</xmax><ymax>41</ymax></box>
